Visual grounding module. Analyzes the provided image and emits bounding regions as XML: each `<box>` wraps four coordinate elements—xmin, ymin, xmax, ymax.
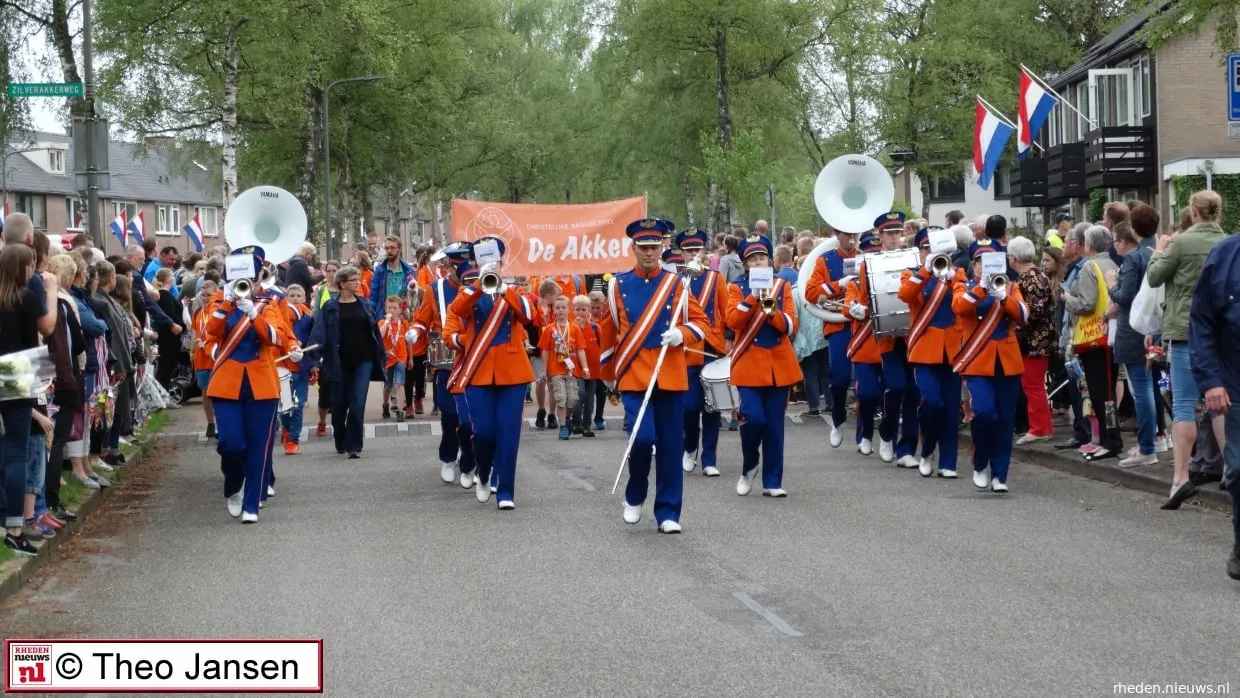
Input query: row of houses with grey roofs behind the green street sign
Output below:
<box><xmin>2</xmin><ymin>133</ymin><xmax>223</xmax><ymax>254</ymax></box>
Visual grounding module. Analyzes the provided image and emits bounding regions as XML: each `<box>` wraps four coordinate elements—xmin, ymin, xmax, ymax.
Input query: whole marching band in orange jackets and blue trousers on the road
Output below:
<box><xmin>200</xmin><ymin>155</ymin><xmax>1028</xmax><ymax>533</ymax></box>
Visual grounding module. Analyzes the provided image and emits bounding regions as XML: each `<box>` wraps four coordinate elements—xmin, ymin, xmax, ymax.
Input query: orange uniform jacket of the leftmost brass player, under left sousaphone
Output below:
<box><xmin>207</xmin><ymin>300</ymin><xmax>298</xmax><ymax>400</ymax></box>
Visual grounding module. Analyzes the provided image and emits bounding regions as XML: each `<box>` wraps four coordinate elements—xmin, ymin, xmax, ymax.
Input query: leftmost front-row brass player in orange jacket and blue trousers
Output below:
<box><xmin>207</xmin><ymin>247</ymin><xmax>303</xmax><ymax>523</ymax></box>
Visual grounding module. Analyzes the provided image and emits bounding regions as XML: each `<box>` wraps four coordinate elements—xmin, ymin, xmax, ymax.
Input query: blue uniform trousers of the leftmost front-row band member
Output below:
<box><xmin>212</xmin><ymin>381</ymin><xmax>280</xmax><ymax>515</ymax></box>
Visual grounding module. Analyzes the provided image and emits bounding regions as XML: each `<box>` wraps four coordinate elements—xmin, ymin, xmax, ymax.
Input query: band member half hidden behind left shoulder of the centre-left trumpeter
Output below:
<box><xmin>407</xmin><ymin>242</ymin><xmax>477</xmax><ymax>490</ymax></box>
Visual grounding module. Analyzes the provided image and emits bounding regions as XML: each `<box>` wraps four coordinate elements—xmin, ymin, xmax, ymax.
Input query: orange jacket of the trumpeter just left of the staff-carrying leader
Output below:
<box><xmin>448</xmin><ymin>281</ymin><xmax>534</xmax><ymax>386</ymax></box>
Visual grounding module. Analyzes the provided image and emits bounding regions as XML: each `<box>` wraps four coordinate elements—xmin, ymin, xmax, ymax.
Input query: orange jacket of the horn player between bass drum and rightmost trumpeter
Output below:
<box><xmin>899</xmin><ymin>267</ymin><xmax>965</xmax><ymax>366</ymax></box>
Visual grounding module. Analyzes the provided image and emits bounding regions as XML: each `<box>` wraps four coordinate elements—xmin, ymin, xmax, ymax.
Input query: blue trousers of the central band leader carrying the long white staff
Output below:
<box><xmin>620</xmin><ymin>387</ymin><xmax>684</xmax><ymax>523</ymax></box>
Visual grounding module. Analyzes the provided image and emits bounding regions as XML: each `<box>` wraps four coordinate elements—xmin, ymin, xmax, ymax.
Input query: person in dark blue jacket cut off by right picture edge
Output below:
<box><xmin>1188</xmin><ymin>236</ymin><xmax>1240</xmax><ymax>580</ymax></box>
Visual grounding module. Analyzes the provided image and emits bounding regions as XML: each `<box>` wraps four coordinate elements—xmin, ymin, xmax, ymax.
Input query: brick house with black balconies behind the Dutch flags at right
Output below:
<box><xmin>1012</xmin><ymin>4</ymin><xmax>1240</xmax><ymax>223</ymax></box>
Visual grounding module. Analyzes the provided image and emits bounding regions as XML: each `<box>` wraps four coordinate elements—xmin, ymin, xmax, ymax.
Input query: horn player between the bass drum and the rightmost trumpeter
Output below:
<box><xmin>900</xmin><ymin>227</ymin><xmax>965</xmax><ymax>477</ymax></box>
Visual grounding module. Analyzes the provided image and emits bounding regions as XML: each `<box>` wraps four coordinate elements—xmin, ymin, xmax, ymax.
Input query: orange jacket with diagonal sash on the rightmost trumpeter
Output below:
<box><xmin>951</xmin><ymin>283</ymin><xmax>1029</xmax><ymax>376</ymax></box>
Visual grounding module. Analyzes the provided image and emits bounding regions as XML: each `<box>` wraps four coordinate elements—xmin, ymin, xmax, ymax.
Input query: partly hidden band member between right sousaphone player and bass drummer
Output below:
<box><xmin>831</xmin><ymin>232</ymin><xmax>890</xmax><ymax>456</ymax></box>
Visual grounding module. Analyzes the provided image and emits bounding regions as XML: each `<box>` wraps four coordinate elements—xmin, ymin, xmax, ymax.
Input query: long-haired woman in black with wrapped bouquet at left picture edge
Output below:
<box><xmin>0</xmin><ymin>244</ymin><xmax>50</xmax><ymax>557</ymax></box>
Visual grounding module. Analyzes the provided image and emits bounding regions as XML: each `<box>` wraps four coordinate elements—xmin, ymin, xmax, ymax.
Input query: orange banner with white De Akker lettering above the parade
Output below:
<box><xmin>453</xmin><ymin>197</ymin><xmax>646</xmax><ymax>276</ymax></box>
